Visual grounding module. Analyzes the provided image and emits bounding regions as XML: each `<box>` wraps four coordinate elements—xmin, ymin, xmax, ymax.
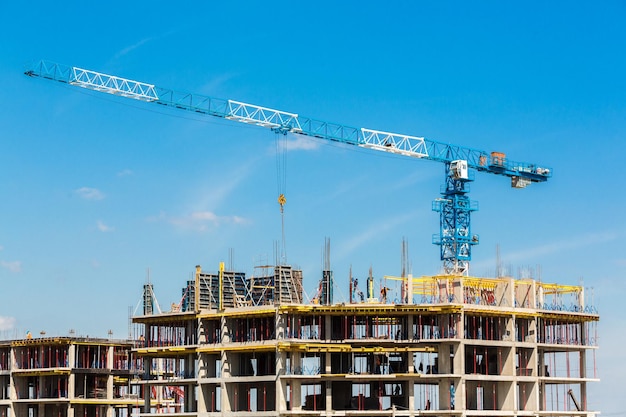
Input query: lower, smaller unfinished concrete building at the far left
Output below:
<box><xmin>0</xmin><ymin>335</ymin><xmax>143</xmax><ymax>417</ymax></box>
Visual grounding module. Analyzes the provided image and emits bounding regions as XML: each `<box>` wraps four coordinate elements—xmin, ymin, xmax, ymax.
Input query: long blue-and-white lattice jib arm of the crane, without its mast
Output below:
<box><xmin>25</xmin><ymin>61</ymin><xmax>552</xmax><ymax>182</ymax></box>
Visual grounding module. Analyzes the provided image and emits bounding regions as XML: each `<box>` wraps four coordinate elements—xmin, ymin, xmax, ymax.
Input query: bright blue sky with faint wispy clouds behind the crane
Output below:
<box><xmin>0</xmin><ymin>1</ymin><xmax>626</xmax><ymax>415</ymax></box>
